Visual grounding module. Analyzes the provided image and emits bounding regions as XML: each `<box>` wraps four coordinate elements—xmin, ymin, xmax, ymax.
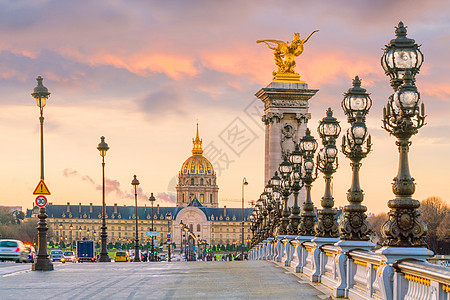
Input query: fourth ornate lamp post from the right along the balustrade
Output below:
<box><xmin>298</xmin><ymin>128</ymin><xmax>317</xmax><ymax>236</ymax></box>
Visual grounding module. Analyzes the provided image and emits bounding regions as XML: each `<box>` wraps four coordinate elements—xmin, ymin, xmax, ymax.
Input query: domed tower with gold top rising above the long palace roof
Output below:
<box><xmin>177</xmin><ymin>123</ymin><xmax>219</xmax><ymax>207</ymax></box>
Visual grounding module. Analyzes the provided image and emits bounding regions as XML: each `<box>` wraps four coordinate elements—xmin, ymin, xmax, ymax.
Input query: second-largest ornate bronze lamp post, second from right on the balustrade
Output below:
<box><xmin>339</xmin><ymin>76</ymin><xmax>372</xmax><ymax>241</ymax></box>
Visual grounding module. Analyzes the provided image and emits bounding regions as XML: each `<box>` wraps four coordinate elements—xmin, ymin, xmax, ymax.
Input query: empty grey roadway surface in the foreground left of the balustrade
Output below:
<box><xmin>0</xmin><ymin>261</ymin><xmax>328</xmax><ymax>299</ymax></box>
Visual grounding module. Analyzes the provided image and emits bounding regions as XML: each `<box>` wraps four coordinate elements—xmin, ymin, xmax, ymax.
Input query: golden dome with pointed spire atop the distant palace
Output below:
<box><xmin>181</xmin><ymin>123</ymin><xmax>214</xmax><ymax>175</ymax></box>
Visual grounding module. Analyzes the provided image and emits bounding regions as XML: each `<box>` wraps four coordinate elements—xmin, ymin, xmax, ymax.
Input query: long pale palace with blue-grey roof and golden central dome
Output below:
<box><xmin>26</xmin><ymin>124</ymin><xmax>253</xmax><ymax>247</ymax></box>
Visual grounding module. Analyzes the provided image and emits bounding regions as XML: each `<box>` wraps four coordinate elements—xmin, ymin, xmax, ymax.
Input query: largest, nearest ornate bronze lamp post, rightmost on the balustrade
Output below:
<box><xmin>382</xmin><ymin>22</ymin><xmax>427</xmax><ymax>247</ymax></box>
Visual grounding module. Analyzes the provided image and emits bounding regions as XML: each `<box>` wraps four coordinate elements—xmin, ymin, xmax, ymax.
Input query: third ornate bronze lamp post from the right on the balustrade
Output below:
<box><xmin>315</xmin><ymin>108</ymin><xmax>341</xmax><ymax>238</ymax></box>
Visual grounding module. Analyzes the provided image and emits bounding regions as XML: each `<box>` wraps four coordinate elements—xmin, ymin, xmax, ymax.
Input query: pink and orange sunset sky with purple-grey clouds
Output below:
<box><xmin>0</xmin><ymin>0</ymin><xmax>450</xmax><ymax>212</ymax></box>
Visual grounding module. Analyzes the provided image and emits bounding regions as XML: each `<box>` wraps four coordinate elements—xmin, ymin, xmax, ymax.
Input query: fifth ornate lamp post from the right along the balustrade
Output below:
<box><xmin>288</xmin><ymin>144</ymin><xmax>302</xmax><ymax>235</ymax></box>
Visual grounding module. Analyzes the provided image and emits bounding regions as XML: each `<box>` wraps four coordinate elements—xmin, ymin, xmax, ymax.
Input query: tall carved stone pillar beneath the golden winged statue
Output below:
<box><xmin>255</xmin><ymin>82</ymin><xmax>318</xmax><ymax>206</ymax></box>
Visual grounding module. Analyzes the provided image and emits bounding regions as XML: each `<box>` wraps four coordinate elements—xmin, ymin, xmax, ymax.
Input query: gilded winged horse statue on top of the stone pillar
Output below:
<box><xmin>256</xmin><ymin>30</ymin><xmax>319</xmax><ymax>83</ymax></box>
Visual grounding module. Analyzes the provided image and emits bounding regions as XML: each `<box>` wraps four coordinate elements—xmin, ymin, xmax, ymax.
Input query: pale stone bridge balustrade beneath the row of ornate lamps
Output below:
<box><xmin>249</xmin><ymin>236</ymin><xmax>450</xmax><ymax>300</ymax></box>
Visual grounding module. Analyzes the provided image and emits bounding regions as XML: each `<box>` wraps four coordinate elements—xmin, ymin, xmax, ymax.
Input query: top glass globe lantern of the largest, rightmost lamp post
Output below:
<box><xmin>381</xmin><ymin>22</ymin><xmax>423</xmax><ymax>90</ymax></box>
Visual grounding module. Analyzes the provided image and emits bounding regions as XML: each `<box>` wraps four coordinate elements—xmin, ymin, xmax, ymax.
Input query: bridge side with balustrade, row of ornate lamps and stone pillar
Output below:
<box><xmin>249</xmin><ymin>22</ymin><xmax>450</xmax><ymax>300</ymax></box>
